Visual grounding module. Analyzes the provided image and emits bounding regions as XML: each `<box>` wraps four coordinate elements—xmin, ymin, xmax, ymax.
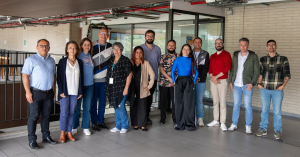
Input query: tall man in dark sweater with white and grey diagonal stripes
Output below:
<box><xmin>90</xmin><ymin>26</ymin><xmax>113</xmax><ymax>131</ymax></box>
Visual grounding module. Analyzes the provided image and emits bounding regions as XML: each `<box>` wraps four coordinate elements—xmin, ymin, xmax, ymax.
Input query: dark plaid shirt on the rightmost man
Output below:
<box><xmin>260</xmin><ymin>53</ymin><xmax>291</xmax><ymax>90</ymax></box>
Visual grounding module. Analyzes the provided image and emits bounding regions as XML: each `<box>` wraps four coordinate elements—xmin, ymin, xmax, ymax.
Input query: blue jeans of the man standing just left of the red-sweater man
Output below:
<box><xmin>195</xmin><ymin>82</ymin><xmax>206</xmax><ymax>119</ymax></box>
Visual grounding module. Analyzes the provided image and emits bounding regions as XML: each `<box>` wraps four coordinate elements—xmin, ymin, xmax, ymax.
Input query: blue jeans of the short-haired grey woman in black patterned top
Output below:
<box><xmin>115</xmin><ymin>90</ymin><xmax>129</xmax><ymax>130</ymax></box>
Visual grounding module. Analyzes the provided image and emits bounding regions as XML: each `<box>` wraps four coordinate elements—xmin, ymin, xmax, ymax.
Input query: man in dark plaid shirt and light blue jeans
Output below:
<box><xmin>255</xmin><ymin>40</ymin><xmax>291</xmax><ymax>141</ymax></box>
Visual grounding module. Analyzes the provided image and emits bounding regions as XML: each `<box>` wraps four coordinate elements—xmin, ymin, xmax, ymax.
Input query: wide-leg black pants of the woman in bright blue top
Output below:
<box><xmin>175</xmin><ymin>76</ymin><xmax>196</xmax><ymax>131</ymax></box>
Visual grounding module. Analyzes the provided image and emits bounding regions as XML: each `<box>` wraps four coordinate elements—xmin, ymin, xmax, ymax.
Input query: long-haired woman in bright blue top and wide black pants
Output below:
<box><xmin>171</xmin><ymin>44</ymin><xmax>198</xmax><ymax>131</ymax></box>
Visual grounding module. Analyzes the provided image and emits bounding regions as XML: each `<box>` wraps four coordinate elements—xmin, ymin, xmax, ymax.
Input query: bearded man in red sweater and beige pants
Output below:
<box><xmin>207</xmin><ymin>39</ymin><xmax>231</xmax><ymax>131</ymax></box>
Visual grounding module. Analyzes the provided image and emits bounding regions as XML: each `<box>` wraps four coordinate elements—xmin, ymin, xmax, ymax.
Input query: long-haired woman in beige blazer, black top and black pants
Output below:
<box><xmin>130</xmin><ymin>46</ymin><xmax>155</xmax><ymax>131</ymax></box>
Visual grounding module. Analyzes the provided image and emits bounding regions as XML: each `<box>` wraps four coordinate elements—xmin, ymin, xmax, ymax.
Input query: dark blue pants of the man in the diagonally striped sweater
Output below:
<box><xmin>90</xmin><ymin>82</ymin><xmax>105</xmax><ymax>124</ymax></box>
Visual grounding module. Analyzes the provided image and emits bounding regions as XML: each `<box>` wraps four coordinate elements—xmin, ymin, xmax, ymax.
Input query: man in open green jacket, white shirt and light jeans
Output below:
<box><xmin>228</xmin><ymin>38</ymin><xmax>260</xmax><ymax>134</ymax></box>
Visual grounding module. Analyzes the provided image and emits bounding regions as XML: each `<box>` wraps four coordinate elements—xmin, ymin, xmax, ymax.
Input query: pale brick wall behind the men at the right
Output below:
<box><xmin>225</xmin><ymin>2</ymin><xmax>300</xmax><ymax>115</ymax></box>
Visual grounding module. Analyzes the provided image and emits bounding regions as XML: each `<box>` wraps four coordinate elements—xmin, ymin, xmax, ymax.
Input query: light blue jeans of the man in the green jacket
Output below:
<box><xmin>232</xmin><ymin>85</ymin><xmax>254</xmax><ymax>127</ymax></box>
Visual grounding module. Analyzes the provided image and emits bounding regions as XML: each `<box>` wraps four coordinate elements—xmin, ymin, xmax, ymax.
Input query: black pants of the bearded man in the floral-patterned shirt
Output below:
<box><xmin>159</xmin><ymin>86</ymin><xmax>176</xmax><ymax>123</ymax></box>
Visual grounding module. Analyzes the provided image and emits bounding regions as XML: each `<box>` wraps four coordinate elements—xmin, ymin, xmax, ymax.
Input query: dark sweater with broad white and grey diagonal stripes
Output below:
<box><xmin>92</xmin><ymin>43</ymin><xmax>113</xmax><ymax>82</ymax></box>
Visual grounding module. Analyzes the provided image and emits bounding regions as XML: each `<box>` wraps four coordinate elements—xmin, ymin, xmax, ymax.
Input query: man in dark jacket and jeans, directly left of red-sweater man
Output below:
<box><xmin>193</xmin><ymin>37</ymin><xmax>209</xmax><ymax>127</ymax></box>
